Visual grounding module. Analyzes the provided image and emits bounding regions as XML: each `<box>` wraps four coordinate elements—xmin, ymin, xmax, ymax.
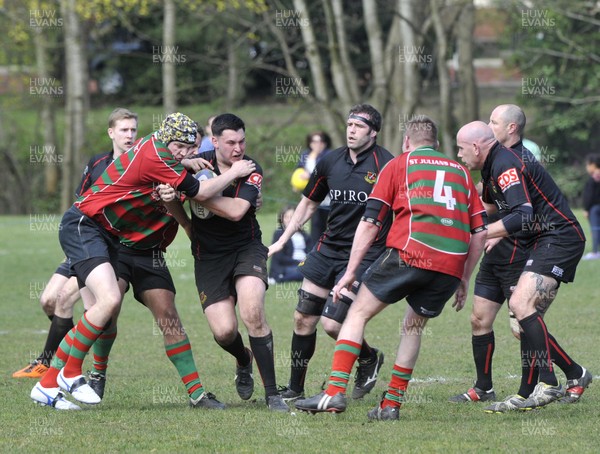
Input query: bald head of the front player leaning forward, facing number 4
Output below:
<box><xmin>456</xmin><ymin>121</ymin><xmax>496</xmax><ymax>170</ymax></box>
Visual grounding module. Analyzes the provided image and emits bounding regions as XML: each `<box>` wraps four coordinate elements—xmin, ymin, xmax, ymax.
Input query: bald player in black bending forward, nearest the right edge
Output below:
<box><xmin>456</xmin><ymin>118</ymin><xmax>591</xmax><ymax>412</ymax></box>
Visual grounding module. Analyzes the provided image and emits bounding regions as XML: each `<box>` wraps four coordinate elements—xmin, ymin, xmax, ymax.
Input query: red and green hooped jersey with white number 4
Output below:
<box><xmin>369</xmin><ymin>147</ymin><xmax>485</xmax><ymax>279</ymax></box>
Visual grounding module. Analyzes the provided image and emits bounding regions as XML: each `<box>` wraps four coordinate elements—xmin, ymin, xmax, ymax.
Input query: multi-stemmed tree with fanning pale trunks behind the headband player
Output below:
<box><xmin>265</xmin><ymin>0</ymin><xmax>423</xmax><ymax>153</ymax></box>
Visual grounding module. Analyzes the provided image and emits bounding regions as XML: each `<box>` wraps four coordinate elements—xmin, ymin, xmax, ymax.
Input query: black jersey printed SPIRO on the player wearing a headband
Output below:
<box><xmin>303</xmin><ymin>144</ymin><xmax>394</xmax><ymax>260</ymax></box>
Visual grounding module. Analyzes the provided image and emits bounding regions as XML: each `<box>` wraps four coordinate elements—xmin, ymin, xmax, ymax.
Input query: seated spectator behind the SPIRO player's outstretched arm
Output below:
<box><xmin>269</xmin><ymin>205</ymin><xmax>313</xmax><ymax>283</ymax></box>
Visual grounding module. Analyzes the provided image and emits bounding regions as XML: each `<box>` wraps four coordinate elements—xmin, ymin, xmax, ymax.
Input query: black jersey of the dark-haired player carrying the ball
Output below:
<box><xmin>192</xmin><ymin>150</ymin><xmax>263</xmax><ymax>255</ymax></box>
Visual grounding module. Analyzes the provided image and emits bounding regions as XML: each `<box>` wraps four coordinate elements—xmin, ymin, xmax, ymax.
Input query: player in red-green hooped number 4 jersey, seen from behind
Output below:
<box><xmin>296</xmin><ymin>117</ymin><xmax>486</xmax><ymax>420</ymax></box>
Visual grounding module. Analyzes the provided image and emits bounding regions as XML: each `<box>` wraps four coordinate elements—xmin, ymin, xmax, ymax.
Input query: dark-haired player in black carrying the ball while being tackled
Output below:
<box><xmin>161</xmin><ymin>113</ymin><xmax>289</xmax><ymax>412</ymax></box>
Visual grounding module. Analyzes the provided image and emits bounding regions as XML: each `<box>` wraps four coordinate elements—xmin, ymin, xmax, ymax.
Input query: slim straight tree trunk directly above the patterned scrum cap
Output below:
<box><xmin>160</xmin><ymin>0</ymin><xmax>177</xmax><ymax>114</ymax></box>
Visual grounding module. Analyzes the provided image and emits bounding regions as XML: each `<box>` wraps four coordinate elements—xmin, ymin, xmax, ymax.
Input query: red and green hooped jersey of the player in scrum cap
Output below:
<box><xmin>75</xmin><ymin>134</ymin><xmax>187</xmax><ymax>249</ymax></box>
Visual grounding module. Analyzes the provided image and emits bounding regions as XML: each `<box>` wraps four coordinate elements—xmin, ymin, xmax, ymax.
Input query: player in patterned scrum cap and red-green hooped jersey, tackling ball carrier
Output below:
<box><xmin>32</xmin><ymin>113</ymin><xmax>255</xmax><ymax>404</ymax></box>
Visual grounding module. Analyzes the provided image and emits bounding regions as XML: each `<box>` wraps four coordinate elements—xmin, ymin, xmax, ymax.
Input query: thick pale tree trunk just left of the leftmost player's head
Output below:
<box><xmin>61</xmin><ymin>0</ymin><xmax>88</xmax><ymax>211</ymax></box>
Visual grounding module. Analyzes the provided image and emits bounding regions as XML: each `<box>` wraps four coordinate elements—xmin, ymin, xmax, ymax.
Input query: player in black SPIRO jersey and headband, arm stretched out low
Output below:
<box><xmin>269</xmin><ymin>104</ymin><xmax>393</xmax><ymax>401</ymax></box>
